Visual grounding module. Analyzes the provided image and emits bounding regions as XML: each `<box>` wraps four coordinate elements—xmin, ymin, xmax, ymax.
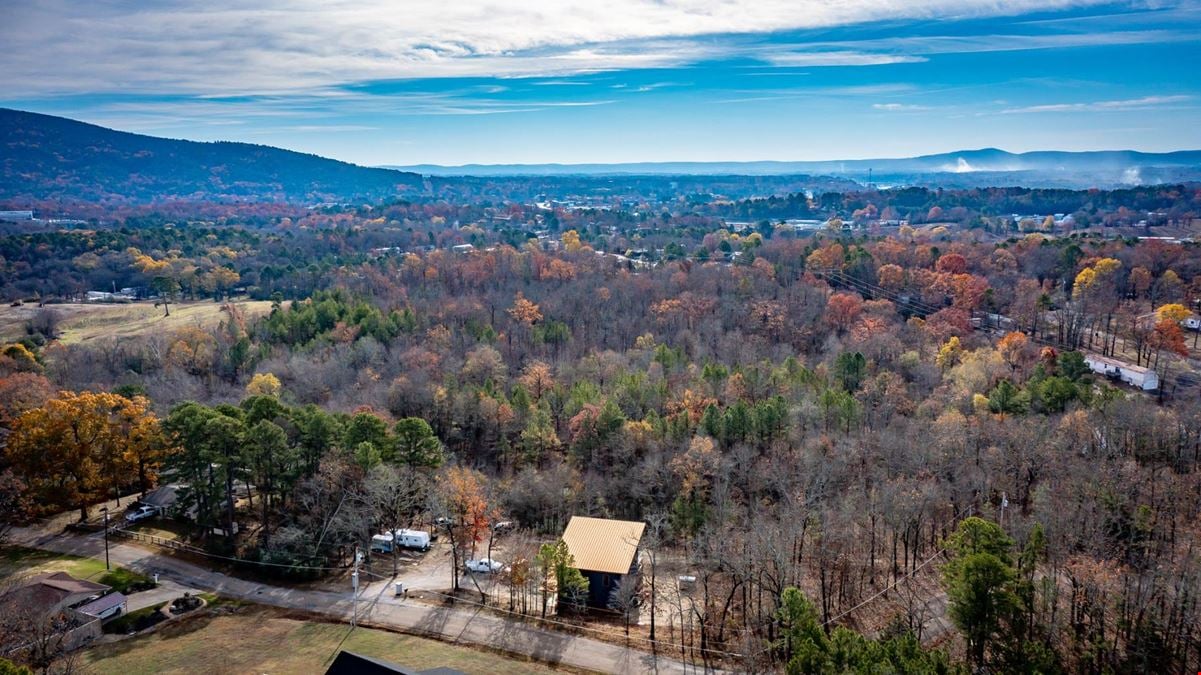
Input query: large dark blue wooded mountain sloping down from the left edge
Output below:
<box><xmin>0</xmin><ymin>108</ymin><xmax>422</xmax><ymax>203</ymax></box>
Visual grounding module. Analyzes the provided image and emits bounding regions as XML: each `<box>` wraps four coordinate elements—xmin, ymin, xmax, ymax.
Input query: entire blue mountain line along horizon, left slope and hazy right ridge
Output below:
<box><xmin>0</xmin><ymin>108</ymin><xmax>1201</xmax><ymax>199</ymax></box>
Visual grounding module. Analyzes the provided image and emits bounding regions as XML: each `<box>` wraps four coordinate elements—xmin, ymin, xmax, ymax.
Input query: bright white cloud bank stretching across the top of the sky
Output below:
<box><xmin>0</xmin><ymin>0</ymin><xmax>1119</xmax><ymax>95</ymax></box>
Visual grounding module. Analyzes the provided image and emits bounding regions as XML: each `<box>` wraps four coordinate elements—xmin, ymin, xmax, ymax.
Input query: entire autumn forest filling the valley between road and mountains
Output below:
<box><xmin>0</xmin><ymin>181</ymin><xmax>1201</xmax><ymax>673</ymax></box>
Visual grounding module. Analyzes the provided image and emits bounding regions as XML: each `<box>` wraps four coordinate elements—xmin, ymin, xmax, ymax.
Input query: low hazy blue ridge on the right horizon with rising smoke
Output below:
<box><xmin>388</xmin><ymin>148</ymin><xmax>1201</xmax><ymax>184</ymax></box>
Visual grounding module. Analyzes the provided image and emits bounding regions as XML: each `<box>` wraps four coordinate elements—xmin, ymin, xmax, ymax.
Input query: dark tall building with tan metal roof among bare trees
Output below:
<box><xmin>563</xmin><ymin>515</ymin><xmax>646</xmax><ymax>608</ymax></box>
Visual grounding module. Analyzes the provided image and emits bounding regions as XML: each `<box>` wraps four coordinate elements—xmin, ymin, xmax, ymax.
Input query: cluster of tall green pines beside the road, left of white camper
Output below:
<box><xmin>163</xmin><ymin>394</ymin><xmax>446</xmax><ymax>564</ymax></box>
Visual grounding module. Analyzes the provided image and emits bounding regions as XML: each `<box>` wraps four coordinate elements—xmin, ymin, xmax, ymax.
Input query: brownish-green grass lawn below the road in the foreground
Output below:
<box><xmin>82</xmin><ymin>608</ymin><xmax>571</xmax><ymax>675</ymax></box>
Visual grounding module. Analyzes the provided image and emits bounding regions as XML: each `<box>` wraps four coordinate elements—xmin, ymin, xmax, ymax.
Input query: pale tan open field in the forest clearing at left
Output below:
<box><xmin>0</xmin><ymin>300</ymin><xmax>271</xmax><ymax>344</ymax></box>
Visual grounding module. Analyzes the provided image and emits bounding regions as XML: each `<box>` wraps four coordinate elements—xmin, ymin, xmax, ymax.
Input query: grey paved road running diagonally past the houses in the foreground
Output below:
<box><xmin>11</xmin><ymin>521</ymin><xmax>697</xmax><ymax>674</ymax></box>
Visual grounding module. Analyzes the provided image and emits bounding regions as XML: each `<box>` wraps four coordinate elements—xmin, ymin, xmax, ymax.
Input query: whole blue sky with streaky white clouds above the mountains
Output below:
<box><xmin>0</xmin><ymin>0</ymin><xmax>1201</xmax><ymax>165</ymax></box>
